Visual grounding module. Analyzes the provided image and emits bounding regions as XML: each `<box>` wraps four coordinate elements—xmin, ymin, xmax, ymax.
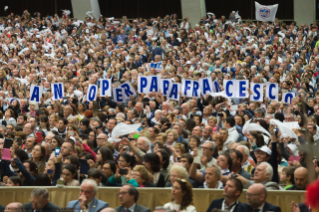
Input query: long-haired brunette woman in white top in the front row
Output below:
<box><xmin>164</xmin><ymin>178</ymin><xmax>196</xmax><ymax>212</ymax></box>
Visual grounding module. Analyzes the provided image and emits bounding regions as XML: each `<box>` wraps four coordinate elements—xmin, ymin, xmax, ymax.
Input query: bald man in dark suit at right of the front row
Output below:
<box><xmin>238</xmin><ymin>183</ymin><xmax>281</xmax><ymax>212</ymax></box>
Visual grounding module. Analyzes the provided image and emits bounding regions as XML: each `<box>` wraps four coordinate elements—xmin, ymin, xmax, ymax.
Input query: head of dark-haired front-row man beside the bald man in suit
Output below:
<box><xmin>223</xmin><ymin>177</ymin><xmax>244</xmax><ymax>199</ymax></box>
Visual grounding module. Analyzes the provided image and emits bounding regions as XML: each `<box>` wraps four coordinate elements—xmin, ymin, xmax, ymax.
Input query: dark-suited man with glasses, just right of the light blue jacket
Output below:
<box><xmin>114</xmin><ymin>184</ymin><xmax>151</xmax><ymax>212</ymax></box>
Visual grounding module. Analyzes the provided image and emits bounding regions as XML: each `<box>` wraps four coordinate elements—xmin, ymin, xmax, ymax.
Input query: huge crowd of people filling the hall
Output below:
<box><xmin>0</xmin><ymin>5</ymin><xmax>319</xmax><ymax>212</ymax></box>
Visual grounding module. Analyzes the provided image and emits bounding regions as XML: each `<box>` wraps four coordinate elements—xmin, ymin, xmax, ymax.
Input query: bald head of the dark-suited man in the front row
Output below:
<box><xmin>246</xmin><ymin>183</ymin><xmax>267</xmax><ymax>209</ymax></box>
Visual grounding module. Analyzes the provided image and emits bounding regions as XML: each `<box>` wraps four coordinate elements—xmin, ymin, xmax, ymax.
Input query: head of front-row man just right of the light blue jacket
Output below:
<box><xmin>118</xmin><ymin>184</ymin><xmax>139</xmax><ymax>208</ymax></box>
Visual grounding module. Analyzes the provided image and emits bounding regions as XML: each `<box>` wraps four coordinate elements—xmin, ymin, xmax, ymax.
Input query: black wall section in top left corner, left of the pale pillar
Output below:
<box><xmin>0</xmin><ymin>0</ymin><xmax>73</xmax><ymax>17</ymax></box>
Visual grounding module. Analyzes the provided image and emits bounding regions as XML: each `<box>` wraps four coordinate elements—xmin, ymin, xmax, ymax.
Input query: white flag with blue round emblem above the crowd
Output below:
<box><xmin>255</xmin><ymin>2</ymin><xmax>278</xmax><ymax>22</ymax></box>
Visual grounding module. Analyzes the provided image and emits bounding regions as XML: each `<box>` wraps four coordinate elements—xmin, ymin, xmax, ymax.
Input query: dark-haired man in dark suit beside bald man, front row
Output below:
<box><xmin>206</xmin><ymin>177</ymin><xmax>244</xmax><ymax>212</ymax></box>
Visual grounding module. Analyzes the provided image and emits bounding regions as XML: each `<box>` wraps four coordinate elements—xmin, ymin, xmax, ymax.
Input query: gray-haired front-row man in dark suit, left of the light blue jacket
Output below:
<box><xmin>23</xmin><ymin>188</ymin><xmax>59</xmax><ymax>212</ymax></box>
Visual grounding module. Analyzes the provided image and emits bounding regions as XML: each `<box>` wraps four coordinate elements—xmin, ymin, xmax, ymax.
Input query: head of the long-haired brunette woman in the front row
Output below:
<box><xmin>171</xmin><ymin>178</ymin><xmax>193</xmax><ymax>210</ymax></box>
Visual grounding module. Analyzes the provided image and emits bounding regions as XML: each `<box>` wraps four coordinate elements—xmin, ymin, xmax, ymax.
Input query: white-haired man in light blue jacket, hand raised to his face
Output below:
<box><xmin>67</xmin><ymin>179</ymin><xmax>109</xmax><ymax>212</ymax></box>
